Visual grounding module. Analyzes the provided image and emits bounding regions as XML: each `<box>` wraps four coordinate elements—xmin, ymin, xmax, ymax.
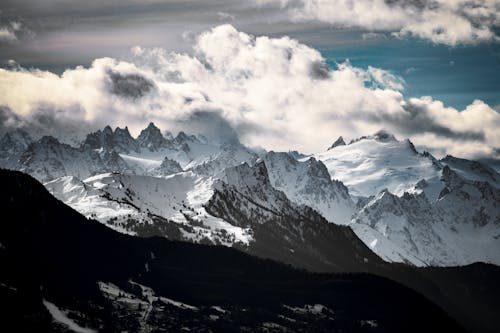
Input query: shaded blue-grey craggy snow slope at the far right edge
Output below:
<box><xmin>350</xmin><ymin>166</ymin><xmax>500</xmax><ymax>266</ymax></box>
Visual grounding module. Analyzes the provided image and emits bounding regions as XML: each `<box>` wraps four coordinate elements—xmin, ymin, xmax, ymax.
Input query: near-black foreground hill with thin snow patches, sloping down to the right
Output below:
<box><xmin>0</xmin><ymin>170</ymin><xmax>462</xmax><ymax>332</ymax></box>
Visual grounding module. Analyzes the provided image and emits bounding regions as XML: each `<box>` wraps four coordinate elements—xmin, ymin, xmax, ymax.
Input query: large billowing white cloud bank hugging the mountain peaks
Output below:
<box><xmin>0</xmin><ymin>25</ymin><xmax>500</xmax><ymax>157</ymax></box>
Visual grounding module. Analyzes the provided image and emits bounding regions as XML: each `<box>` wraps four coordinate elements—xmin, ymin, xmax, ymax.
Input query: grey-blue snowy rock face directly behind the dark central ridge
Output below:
<box><xmin>262</xmin><ymin>152</ymin><xmax>356</xmax><ymax>225</ymax></box>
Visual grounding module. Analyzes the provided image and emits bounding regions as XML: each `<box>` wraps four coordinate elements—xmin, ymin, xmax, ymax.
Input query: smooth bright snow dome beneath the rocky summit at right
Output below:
<box><xmin>313</xmin><ymin>132</ymin><xmax>440</xmax><ymax>197</ymax></box>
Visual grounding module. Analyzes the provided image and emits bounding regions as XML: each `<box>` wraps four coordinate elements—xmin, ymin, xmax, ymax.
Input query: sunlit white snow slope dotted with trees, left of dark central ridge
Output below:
<box><xmin>45</xmin><ymin>172</ymin><xmax>252</xmax><ymax>245</ymax></box>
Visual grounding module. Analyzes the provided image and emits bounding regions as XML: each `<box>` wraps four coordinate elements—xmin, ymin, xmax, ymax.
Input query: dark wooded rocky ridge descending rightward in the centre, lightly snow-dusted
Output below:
<box><xmin>205</xmin><ymin>161</ymin><xmax>380</xmax><ymax>271</ymax></box>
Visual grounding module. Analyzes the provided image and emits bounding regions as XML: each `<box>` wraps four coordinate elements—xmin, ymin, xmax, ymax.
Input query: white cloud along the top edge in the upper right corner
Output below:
<box><xmin>257</xmin><ymin>0</ymin><xmax>500</xmax><ymax>46</ymax></box>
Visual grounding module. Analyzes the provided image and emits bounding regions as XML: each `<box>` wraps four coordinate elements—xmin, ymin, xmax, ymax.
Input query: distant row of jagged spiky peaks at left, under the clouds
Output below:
<box><xmin>0</xmin><ymin>123</ymin><xmax>257</xmax><ymax>182</ymax></box>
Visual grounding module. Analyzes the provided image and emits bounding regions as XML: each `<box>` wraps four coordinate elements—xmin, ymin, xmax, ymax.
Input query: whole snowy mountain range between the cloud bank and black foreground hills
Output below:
<box><xmin>0</xmin><ymin>123</ymin><xmax>500</xmax><ymax>266</ymax></box>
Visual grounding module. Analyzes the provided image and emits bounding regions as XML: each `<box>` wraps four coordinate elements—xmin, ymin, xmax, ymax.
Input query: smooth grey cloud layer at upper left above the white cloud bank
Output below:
<box><xmin>0</xmin><ymin>0</ymin><xmax>360</xmax><ymax>67</ymax></box>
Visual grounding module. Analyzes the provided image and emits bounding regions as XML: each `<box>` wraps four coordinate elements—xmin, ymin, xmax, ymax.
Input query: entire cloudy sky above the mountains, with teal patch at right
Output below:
<box><xmin>0</xmin><ymin>0</ymin><xmax>500</xmax><ymax>159</ymax></box>
